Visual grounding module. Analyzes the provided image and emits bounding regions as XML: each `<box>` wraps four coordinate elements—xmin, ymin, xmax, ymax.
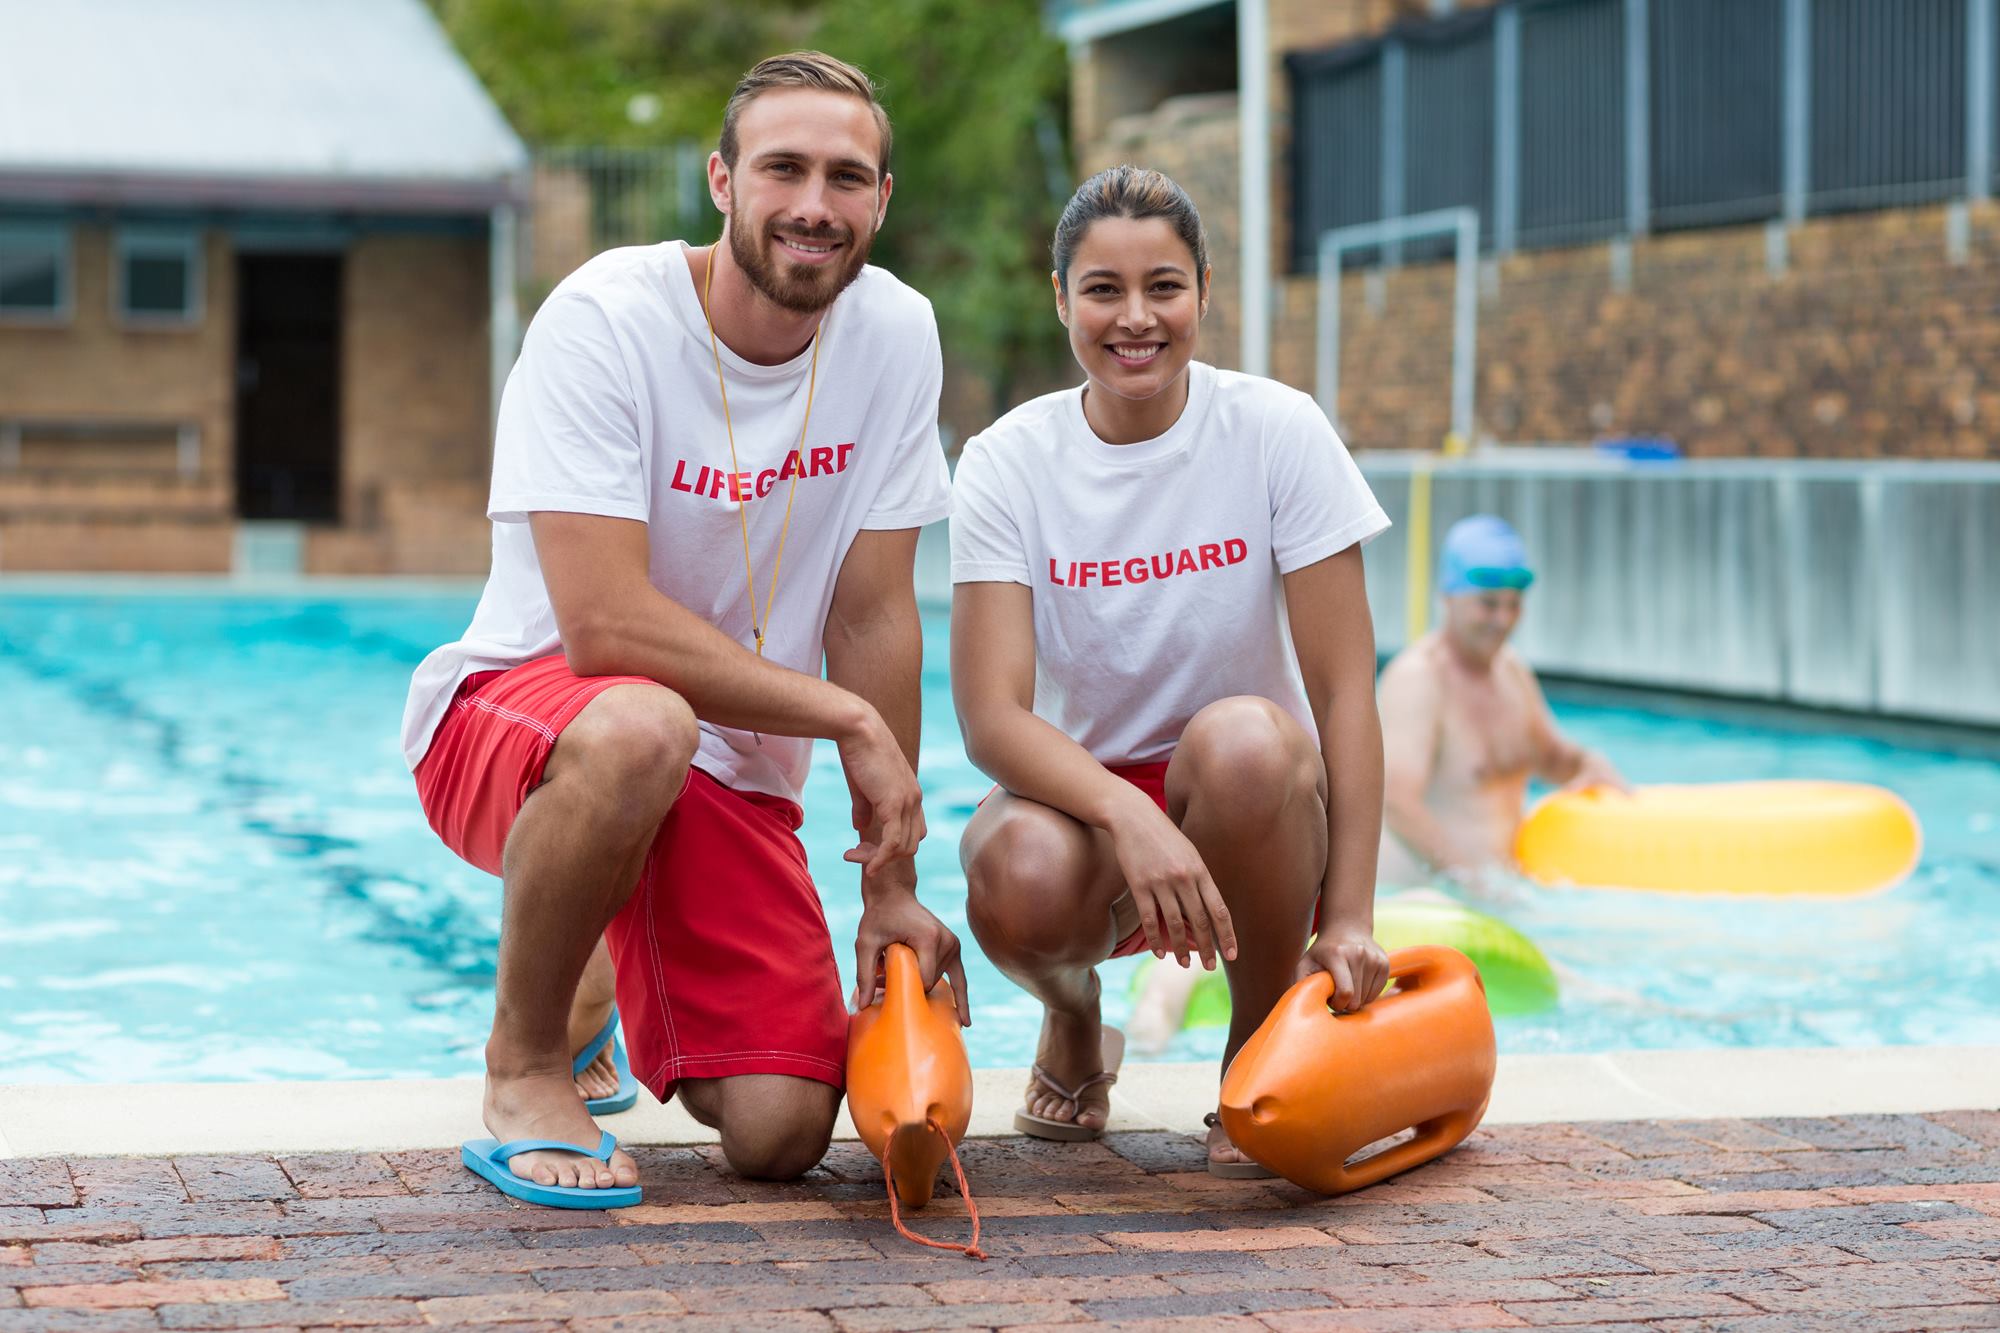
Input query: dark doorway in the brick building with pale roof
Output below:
<box><xmin>236</xmin><ymin>254</ymin><xmax>340</xmax><ymax>520</ymax></box>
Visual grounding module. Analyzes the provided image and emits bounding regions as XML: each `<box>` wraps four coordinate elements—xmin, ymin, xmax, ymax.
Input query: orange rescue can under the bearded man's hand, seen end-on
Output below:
<box><xmin>848</xmin><ymin>932</ymin><xmax>972</xmax><ymax>1209</ymax></box>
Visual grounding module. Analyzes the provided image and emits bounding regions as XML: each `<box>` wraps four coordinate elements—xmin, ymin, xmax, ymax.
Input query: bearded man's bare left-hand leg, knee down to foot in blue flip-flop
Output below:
<box><xmin>484</xmin><ymin>685</ymin><xmax>698</xmax><ymax>1189</ymax></box>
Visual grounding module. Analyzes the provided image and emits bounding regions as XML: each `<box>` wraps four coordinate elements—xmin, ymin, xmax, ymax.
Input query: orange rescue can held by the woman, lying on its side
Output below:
<box><xmin>1222</xmin><ymin>945</ymin><xmax>1496</xmax><ymax>1195</ymax></box>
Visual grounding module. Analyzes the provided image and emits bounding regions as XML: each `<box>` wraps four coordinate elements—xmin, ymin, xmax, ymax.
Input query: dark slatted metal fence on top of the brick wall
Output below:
<box><xmin>1288</xmin><ymin>0</ymin><xmax>2000</xmax><ymax>272</ymax></box>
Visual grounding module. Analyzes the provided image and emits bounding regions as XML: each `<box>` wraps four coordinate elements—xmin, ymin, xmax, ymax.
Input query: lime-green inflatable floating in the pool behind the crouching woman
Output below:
<box><xmin>1130</xmin><ymin>891</ymin><xmax>1558</xmax><ymax>1027</ymax></box>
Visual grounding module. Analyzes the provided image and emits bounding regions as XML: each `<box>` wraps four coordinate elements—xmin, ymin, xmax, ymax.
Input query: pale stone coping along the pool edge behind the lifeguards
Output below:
<box><xmin>0</xmin><ymin>1047</ymin><xmax>2000</xmax><ymax>1159</ymax></box>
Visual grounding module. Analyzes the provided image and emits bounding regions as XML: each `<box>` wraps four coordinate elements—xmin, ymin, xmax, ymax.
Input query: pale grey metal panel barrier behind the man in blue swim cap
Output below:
<box><xmin>1358</xmin><ymin>450</ymin><xmax>2000</xmax><ymax>725</ymax></box>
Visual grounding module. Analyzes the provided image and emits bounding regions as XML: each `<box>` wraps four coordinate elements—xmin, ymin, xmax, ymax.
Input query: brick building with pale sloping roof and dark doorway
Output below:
<box><xmin>0</xmin><ymin>0</ymin><xmax>528</xmax><ymax>572</ymax></box>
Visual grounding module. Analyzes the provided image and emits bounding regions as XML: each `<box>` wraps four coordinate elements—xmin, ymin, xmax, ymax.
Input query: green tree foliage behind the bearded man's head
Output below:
<box><xmin>430</xmin><ymin>0</ymin><xmax>1068</xmax><ymax>402</ymax></box>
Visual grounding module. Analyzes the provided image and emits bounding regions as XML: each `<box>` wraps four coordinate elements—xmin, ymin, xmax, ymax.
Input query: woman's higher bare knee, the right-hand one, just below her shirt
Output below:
<box><xmin>1168</xmin><ymin>695</ymin><xmax>1322</xmax><ymax>831</ymax></box>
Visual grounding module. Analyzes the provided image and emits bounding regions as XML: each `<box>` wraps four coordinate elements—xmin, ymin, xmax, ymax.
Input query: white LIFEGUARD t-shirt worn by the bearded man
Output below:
<box><xmin>402</xmin><ymin>240</ymin><xmax>950</xmax><ymax>801</ymax></box>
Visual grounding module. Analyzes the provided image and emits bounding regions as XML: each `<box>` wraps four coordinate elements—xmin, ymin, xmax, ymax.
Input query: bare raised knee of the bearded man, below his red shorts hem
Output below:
<box><xmin>548</xmin><ymin>685</ymin><xmax>700</xmax><ymax>831</ymax></box>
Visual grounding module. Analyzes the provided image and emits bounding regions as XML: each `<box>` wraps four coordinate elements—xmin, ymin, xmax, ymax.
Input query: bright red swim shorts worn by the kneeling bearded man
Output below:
<box><xmin>416</xmin><ymin>654</ymin><xmax>848</xmax><ymax>1101</ymax></box>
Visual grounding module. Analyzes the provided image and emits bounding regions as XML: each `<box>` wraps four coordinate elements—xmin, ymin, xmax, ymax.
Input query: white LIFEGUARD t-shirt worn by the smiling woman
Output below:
<box><xmin>952</xmin><ymin>362</ymin><xmax>1388</xmax><ymax>765</ymax></box>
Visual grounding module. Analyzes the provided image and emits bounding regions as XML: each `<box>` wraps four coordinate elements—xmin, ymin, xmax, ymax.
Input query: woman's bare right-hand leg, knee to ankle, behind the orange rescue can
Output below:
<box><xmin>1166</xmin><ymin>697</ymin><xmax>1320</xmax><ymax>1163</ymax></box>
